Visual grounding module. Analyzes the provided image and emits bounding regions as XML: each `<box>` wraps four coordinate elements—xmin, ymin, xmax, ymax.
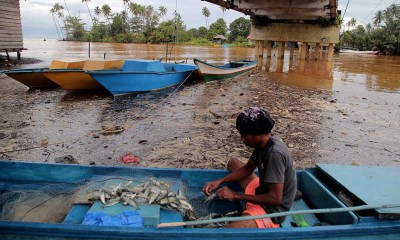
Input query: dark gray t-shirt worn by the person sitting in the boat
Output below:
<box><xmin>250</xmin><ymin>136</ymin><xmax>297</xmax><ymax>223</ymax></box>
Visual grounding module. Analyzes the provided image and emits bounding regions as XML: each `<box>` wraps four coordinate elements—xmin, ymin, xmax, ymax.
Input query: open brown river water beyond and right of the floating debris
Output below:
<box><xmin>2</xmin><ymin>39</ymin><xmax>400</xmax><ymax>165</ymax></box>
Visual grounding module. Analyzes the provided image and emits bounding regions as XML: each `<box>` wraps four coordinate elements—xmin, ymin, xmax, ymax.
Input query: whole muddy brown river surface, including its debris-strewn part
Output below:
<box><xmin>0</xmin><ymin>40</ymin><xmax>400</xmax><ymax>168</ymax></box>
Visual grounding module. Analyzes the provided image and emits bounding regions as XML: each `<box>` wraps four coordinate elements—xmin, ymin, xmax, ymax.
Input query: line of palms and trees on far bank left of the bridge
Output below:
<box><xmin>50</xmin><ymin>0</ymin><xmax>251</xmax><ymax>46</ymax></box>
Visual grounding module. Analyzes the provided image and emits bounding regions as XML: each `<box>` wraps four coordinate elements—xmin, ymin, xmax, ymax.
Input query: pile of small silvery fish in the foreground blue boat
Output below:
<box><xmin>89</xmin><ymin>178</ymin><xmax>196</xmax><ymax>221</ymax></box>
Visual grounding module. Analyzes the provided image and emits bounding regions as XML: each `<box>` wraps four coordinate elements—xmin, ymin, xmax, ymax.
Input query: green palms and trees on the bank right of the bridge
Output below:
<box><xmin>337</xmin><ymin>4</ymin><xmax>400</xmax><ymax>55</ymax></box>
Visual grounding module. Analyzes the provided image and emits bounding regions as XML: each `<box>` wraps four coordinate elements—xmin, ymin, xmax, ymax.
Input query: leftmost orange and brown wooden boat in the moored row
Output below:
<box><xmin>3</xmin><ymin>60</ymin><xmax>85</xmax><ymax>89</ymax></box>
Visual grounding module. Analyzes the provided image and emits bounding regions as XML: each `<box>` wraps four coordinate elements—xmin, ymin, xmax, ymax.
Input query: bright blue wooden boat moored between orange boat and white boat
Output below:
<box><xmin>87</xmin><ymin>59</ymin><xmax>197</xmax><ymax>96</ymax></box>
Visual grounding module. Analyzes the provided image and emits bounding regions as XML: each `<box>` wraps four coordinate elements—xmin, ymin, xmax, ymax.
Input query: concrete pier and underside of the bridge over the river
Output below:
<box><xmin>205</xmin><ymin>0</ymin><xmax>340</xmax><ymax>65</ymax></box>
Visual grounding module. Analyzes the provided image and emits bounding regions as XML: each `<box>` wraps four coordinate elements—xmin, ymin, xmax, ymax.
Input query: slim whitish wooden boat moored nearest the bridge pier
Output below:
<box><xmin>193</xmin><ymin>58</ymin><xmax>257</xmax><ymax>82</ymax></box>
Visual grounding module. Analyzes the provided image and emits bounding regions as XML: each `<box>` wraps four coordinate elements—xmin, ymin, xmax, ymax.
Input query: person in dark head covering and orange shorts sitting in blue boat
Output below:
<box><xmin>203</xmin><ymin>107</ymin><xmax>297</xmax><ymax>228</ymax></box>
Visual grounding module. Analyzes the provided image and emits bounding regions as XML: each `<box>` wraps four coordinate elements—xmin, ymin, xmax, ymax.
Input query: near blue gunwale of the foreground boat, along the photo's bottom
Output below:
<box><xmin>0</xmin><ymin>218</ymin><xmax>400</xmax><ymax>239</ymax></box>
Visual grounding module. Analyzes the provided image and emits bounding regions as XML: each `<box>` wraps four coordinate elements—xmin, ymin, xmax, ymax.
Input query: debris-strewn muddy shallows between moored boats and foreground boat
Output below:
<box><xmin>0</xmin><ymin>70</ymin><xmax>329</xmax><ymax>168</ymax></box>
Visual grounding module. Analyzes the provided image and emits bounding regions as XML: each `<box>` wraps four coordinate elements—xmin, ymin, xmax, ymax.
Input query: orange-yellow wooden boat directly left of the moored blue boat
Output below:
<box><xmin>43</xmin><ymin>60</ymin><xmax>124</xmax><ymax>91</ymax></box>
